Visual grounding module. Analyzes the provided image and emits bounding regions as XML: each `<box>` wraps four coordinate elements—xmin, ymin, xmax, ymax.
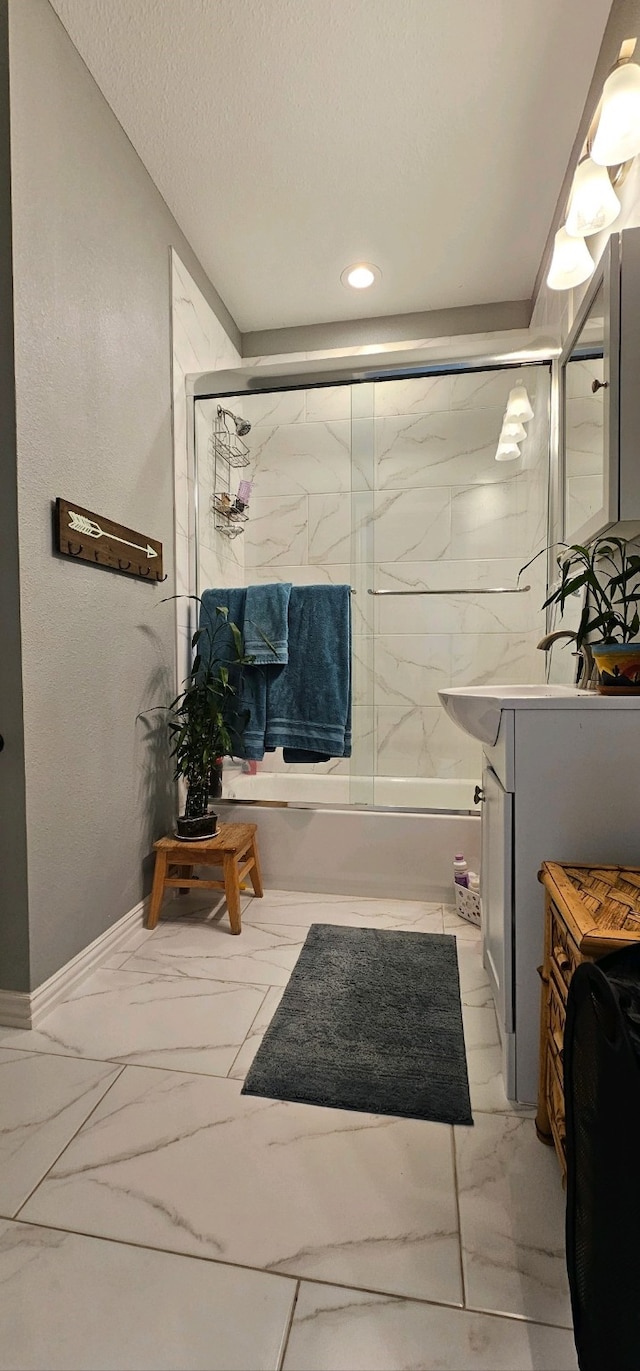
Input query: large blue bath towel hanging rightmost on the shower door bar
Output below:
<box><xmin>264</xmin><ymin>585</ymin><xmax>351</xmax><ymax>762</ymax></box>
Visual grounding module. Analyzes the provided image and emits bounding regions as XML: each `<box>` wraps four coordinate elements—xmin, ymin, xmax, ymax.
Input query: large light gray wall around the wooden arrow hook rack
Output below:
<box><xmin>5</xmin><ymin>0</ymin><xmax>239</xmax><ymax>988</ymax></box>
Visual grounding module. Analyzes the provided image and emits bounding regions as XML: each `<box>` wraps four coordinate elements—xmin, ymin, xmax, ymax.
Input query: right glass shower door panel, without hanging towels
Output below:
<box><xmin>364</xmin><ymin>365</ymin><xmax>550</xmax><ymax>810</ymax></box>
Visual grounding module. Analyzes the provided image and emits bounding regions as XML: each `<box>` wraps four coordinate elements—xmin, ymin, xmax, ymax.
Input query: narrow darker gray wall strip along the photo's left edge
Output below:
<box><xmin>0</xmin><ymin>0</ymin><xmax>29</xmax><ymax>990</ymax></box>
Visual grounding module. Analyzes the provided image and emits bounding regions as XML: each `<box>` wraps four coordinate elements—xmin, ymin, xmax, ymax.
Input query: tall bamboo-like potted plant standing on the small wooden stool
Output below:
<box><xmin>169</xmin><ymin>607</ymin><xmax>252</xmax><ymax>839</ymax></box>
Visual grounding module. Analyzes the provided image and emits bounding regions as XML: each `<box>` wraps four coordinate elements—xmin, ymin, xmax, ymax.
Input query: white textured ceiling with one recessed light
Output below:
<box><xmin>52</xmin><ymin>0</ymin><xmax>611</xmax><ymax>330</ymax></box>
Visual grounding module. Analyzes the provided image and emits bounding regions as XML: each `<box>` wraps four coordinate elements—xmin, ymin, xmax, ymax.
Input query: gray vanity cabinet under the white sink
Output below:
<box><xmin>481</xmin><ymin>694</ymin><xmax>640</xmax><ymax>1105</ymax></box>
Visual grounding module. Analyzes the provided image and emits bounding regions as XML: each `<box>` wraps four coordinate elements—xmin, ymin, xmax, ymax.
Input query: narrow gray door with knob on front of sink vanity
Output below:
<box><xmin>481</xmin><ymin>762</ymin><xmax>514</xmax><ymax>1032</ymax></box>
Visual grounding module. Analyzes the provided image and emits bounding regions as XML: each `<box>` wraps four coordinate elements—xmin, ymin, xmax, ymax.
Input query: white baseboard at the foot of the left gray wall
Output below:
<box><xmin>0</xmin><ymin>899</ymin><xmax>148</xmax><ymax>1028</ymax></box>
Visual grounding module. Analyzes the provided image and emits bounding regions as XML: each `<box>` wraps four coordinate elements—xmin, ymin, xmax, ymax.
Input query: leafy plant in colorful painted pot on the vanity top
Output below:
<box><xmin>539</xmin><ymin>536</ymin><xmax>640</xmax><ymax>695</ymax></box>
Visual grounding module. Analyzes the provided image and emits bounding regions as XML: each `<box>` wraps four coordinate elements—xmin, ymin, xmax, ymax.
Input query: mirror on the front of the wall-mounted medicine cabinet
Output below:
<box><xmin>563</xmin><ymin>284</ymin><xmax>607</xmax><ymax>543</ymax></box>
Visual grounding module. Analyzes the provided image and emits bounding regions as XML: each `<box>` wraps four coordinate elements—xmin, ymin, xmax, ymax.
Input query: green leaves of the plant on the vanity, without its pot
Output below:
<box><xmin>521</xmin><ymin>536</ymin><xmax>640</xmax><ymax>648</ymax></box>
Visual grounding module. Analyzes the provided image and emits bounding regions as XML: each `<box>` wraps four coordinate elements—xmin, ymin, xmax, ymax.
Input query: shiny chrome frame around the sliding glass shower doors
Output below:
<box><xmin>185</xmin><ymin>344</ymin><xmax>561</xmax><ymax>814</ymax></box>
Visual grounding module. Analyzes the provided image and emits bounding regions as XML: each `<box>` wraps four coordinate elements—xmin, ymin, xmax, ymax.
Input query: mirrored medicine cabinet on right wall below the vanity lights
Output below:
<box><xmin>559</xmin><ymin>228</ymin><xmax>640</xmax><ymax>544</ymax></box>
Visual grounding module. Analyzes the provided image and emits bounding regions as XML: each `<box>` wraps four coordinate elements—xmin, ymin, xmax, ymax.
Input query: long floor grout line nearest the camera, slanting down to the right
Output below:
<box><xmin>0</xmin><ymin>1217</ymin><xmax>573</xmax><ymax>1333</ymax></box>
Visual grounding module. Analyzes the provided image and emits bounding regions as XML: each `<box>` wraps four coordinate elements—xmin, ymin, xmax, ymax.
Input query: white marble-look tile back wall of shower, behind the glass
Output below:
<box><xmin>232</xmin><ymin>367</ymin><xmax>548</xmax><ymax>779</ymax></box>
